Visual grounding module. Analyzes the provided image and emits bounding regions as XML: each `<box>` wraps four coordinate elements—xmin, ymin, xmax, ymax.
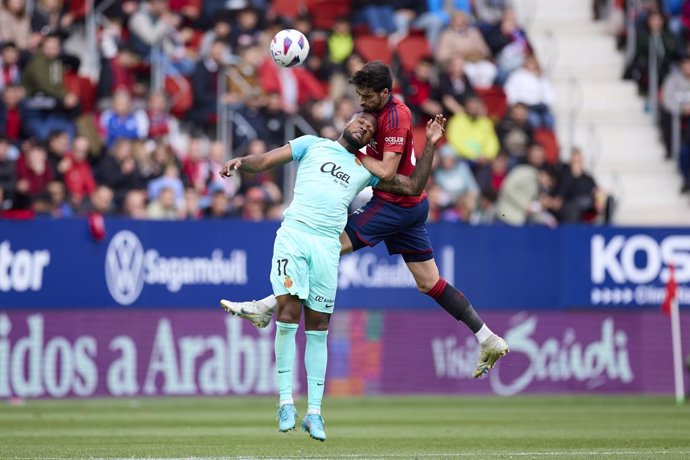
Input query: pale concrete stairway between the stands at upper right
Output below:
<box><xmin>516</xmin><ymin>0</ymin><xmax>690</xmax><ymax>226</ymax></box>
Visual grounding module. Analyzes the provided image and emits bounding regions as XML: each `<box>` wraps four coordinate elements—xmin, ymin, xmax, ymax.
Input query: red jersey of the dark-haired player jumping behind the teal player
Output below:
<box><xmin>367</xmin><ymin>95</ymin><xmax>426</xmax><ymax>208</ymax></box>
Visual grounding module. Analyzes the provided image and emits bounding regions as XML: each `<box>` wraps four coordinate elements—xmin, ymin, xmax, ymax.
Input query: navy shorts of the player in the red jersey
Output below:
<box><xmin>345</xmin><ymin>197</ymin><xmax>434</xmax><ymax>262</ymax></box>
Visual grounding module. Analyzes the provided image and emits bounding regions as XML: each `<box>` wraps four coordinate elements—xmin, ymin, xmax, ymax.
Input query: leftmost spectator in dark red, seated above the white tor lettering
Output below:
<box><xmin>15</xmin><ymin>143</ymin><xmax>53</xmax><ymax>209</ymax></box>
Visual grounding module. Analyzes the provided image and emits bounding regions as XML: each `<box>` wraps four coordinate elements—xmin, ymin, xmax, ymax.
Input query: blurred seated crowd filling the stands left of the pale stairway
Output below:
<box><xmin>0</xmin><ymin>0</ymin><xmax>608</xmax><ymax>226</ymax></box>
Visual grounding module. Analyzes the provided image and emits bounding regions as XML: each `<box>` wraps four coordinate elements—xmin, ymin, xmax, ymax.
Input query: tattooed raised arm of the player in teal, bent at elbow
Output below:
<box><xmin>370</xmin><ymin>115</ymin><xmax>446</xmax><ymax>196</ymax></box>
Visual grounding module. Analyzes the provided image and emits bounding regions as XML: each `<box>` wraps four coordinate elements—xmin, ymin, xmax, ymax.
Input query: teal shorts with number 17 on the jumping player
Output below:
<box><xmin>271</xmin><ymin>225</ymin><xmax>340</xmax><ymax>313</ymax></box>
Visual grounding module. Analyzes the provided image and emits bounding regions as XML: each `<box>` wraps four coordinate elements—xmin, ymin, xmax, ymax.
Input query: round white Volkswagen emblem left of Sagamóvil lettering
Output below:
<box><xmin>105</xmin><ymin>230</ymin><xmax>144</xmax><ymax>305</ymax></box>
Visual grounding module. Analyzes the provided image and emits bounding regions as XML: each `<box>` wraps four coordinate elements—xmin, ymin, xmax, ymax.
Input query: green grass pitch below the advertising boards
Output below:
<box><xmin>0</xmin><ymin>396</ymin><xmax>690</xmax><ymax>459</ymax></box>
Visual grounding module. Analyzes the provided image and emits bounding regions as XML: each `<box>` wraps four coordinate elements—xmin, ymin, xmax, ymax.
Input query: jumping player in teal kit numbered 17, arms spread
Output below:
<box><xmin>220</xmin><ymin>112</ymin><xmax>446</xmax><ymax>441</ymax></box>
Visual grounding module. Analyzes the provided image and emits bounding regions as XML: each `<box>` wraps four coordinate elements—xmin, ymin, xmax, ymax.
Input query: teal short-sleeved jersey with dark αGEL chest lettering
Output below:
<box><xmin>284</xmin><ymin>136</ymin><xmax>379</xmax><ymax>237</ymax></box>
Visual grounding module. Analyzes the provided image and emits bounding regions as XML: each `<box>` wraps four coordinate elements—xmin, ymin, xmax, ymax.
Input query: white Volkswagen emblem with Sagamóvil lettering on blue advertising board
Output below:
<box><xmin>105</xmin><ymin>230</ymin><xmax>248</xmax><ymax>305</ymax></box>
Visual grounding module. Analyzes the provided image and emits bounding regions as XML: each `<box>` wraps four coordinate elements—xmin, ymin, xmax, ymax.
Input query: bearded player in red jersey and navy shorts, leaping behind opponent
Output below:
<box><xmin>221</xmin><ymin>61</ymin><xmax>508</xmax><ymax>378</ymax></box>
